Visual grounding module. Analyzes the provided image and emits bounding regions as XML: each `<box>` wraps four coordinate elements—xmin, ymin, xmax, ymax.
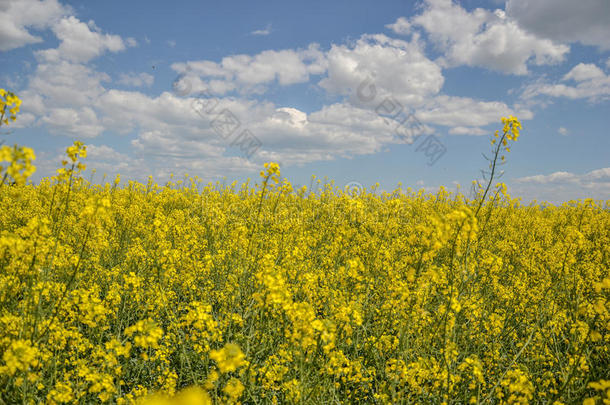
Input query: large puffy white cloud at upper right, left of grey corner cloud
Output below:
<box><xmin>402</xmin><ymin>0</ymin><xmax>569</xmax><ymax>75</ymax></box>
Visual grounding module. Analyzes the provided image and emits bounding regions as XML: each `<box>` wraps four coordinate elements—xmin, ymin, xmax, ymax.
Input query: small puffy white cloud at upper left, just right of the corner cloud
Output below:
<box><xmin>36</xmin><ymin>16</ymin><xmax>125</xmax><ymax>63</ymax></box>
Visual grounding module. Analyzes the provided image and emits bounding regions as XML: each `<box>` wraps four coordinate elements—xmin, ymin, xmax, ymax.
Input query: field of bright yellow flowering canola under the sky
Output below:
<box><xmin>0</xmin><ymin>90</ymin><xmax>610</xmax><ymax>405</ymax></box>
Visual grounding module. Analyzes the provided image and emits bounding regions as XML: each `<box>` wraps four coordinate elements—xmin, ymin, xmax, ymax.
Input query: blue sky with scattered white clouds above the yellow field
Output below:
<box><xmin>0</xmin><ymin>0</ymin><xmax>610</xmax><ymax>203</ymax></box>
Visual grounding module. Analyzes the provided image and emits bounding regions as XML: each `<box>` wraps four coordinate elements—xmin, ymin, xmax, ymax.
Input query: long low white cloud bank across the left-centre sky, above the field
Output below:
<box><xmin>98</xmin><ymin>90</ymin><xmax>406</xmax><ymax>167</ymax></box>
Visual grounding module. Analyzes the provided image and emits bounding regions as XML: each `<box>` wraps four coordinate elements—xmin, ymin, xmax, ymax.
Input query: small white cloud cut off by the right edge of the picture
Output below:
<box><xmin>522</xmin><ymin>63</ymin><xmax>610</xmax><ymax>102</ymax></box>
